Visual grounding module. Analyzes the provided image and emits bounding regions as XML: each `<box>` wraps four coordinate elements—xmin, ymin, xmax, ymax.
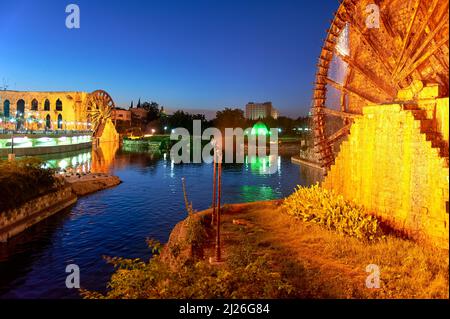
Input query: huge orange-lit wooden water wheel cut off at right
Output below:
<box><xmin>313</xmin><ymin>0</ymin><xmax>449</xmax><ymax>169</ymax></box>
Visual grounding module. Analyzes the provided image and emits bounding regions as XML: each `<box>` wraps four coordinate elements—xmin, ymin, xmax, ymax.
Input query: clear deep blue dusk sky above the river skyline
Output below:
<box><xmin>0</xmin><ymin>0</ymin><xmax>338</xmax><ymax>117</ymax></box>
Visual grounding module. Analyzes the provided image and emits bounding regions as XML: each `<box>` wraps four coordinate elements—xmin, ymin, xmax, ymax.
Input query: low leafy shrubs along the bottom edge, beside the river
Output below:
<box><xmin>80</xmin><ymin>240</ymin><xmax>293</xmax><ymax>299</ymax></box>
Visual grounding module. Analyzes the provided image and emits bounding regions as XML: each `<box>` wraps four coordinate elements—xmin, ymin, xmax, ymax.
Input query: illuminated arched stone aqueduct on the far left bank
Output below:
<box><xmin>0</xmin><ymin>91</ymin><xmax>90</xmax><ymax>130</ymax></box>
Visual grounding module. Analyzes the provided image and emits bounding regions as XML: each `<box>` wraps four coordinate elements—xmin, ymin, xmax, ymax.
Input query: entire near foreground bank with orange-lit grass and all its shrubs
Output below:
<box><xmin>81</xmin><ymin>185</ymin><xmax>449</xmax><ymax>299</ymax></box>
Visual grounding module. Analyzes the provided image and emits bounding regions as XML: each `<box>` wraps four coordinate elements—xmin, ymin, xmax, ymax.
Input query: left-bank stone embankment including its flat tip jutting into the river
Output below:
<box><xmin>0</xmin><ymin>174</ymin><xmax>121</xmax><ymax>242</ymax></box>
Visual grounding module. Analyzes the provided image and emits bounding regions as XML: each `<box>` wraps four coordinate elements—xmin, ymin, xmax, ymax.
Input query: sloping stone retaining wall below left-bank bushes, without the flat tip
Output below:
<box><xmin>0</xmin><ymin>186</ymin><xmax>77</xmax><ymax>242</ymax></box>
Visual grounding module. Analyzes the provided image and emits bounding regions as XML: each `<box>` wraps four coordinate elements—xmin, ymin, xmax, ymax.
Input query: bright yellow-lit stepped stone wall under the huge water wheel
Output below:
<box><xmin>322</xmin><ymin>98</ymin><xmax>449</xmax><ymax>248</ymax></box>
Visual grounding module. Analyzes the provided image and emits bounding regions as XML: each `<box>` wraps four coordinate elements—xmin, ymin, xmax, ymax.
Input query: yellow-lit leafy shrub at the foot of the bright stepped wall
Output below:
<box><xmin>283</xmin><ymin>184</ymin><xmax>383</xmax><ymax>241</ymax></box>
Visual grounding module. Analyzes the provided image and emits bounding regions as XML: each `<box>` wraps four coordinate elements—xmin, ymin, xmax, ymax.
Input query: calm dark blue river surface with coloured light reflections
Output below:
<box><xmin>0</xmin><ymin>149</ymin><xmax>319</xmax><ymax>298</ymax></box>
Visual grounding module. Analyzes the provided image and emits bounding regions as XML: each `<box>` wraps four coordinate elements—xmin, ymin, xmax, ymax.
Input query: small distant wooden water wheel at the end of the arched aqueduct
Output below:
<box><xmin>86</xmin><ymin>90</ymin><xmax>115</xmax><ymax>136</ymax></box>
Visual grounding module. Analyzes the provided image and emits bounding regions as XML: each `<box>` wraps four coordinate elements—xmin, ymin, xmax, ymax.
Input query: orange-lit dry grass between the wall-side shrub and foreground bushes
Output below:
<box><xmin>209</xmin><ymin>202</ymin><xmax>449</xmax><ymax>298</ymax></box>
